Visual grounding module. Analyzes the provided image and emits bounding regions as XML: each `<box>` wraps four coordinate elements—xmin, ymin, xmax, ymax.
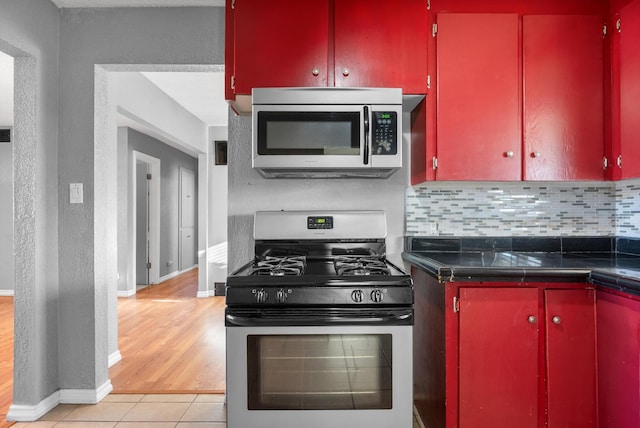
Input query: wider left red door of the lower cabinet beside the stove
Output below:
<box><xmin>458</xmin><ymin>288</ymin><xmax>543</xmax><ymax>428</ymax></box>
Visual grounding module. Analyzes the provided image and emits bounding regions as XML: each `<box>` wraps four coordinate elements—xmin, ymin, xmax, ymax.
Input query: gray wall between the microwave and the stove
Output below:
<box><xmin>228</xmin><ymin>110</ymin><xmax>409</xmax><ymax>272</ymax></box>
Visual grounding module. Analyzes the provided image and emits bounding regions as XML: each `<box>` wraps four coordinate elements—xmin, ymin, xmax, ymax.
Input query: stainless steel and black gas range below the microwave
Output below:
<box><xmin>225</xmin><ymin>211</ymin><xmax>413</xmax><ymax>428</ymax></box>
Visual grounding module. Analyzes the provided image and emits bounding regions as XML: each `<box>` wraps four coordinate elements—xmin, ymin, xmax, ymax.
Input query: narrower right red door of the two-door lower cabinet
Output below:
<box><xmin>544</xmin><ymin>290</ymin><xmax>597</xmax><ymax>428</ymax></box>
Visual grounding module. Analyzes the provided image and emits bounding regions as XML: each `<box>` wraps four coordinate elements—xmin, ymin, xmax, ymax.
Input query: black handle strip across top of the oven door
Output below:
<box><xmin>225</xmin><ymin>309</ymin><xmax>413</xmax><ymax>327</ymax></box>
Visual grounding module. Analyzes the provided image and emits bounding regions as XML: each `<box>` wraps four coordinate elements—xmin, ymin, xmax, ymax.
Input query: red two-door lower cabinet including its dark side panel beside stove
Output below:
<box><xmin>412</xmin><ymin>268</ymin><xmax>596</xmax><ymax>428</ymax></box>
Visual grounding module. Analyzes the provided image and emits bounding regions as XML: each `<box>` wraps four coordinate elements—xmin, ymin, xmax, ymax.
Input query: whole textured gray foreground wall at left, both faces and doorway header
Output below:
<box><xmin>0</xmin><ymin>0</ymin><xmax>224</xmax><ymax>412</ymax></box>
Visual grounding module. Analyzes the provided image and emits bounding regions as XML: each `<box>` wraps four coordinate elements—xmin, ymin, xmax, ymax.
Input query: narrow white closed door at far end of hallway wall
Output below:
<box><xmin>180</xmin><ymin>168</ymin><xmax>196</xmax><ymax>271</ymax></box>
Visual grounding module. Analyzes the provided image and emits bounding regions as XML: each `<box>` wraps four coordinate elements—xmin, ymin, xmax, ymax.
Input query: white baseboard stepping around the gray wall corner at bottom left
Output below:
<box><xmin>7</xmin><ymin>380</ymin><xmax>113</xmax><ymax>422</ymax></box>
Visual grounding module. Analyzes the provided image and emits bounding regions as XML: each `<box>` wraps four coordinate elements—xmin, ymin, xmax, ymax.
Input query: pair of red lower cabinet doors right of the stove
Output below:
<box><xmin>452</xmin><ymin>287</ymin><xmax>597</xmax><ymax>428</ymax></box>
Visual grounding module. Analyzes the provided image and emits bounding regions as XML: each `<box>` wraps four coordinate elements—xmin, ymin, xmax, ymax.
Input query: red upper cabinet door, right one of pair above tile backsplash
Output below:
<box><xmin>522</xmin><ymin>15</ymin><xmax>604</xmax><ymax>180</ymax></box>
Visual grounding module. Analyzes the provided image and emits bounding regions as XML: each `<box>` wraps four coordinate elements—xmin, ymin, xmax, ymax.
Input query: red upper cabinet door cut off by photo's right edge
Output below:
<box><xmin>619</xmin><ymin>0</ymin><xmax>640</xmax><ymax>178</ymax></box>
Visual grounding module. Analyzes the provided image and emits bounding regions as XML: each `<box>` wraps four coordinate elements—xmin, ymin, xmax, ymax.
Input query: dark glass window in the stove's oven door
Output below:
<box><xmin>247</xmin><ymin>334</ymin><xmax>392</xmax><ymax>410</ymax></box>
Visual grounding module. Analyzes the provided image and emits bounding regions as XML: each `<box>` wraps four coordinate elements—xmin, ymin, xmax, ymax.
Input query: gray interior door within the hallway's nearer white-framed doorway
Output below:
<box><xmin>136</xmin><ymin>161</ymin><xmax>149</xmax><ymax>285</ymax></box>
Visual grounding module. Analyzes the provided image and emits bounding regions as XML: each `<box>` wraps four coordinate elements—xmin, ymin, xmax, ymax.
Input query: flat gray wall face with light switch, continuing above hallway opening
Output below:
<box><xmin>58</xmin><ymin>8</ymin><xmax>224</xmax><ymax>389</ymax></box>
